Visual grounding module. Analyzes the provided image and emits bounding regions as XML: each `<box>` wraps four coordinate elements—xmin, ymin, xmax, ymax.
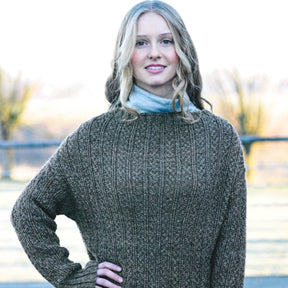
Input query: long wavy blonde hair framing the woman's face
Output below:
<box><xmin>105</xmin><ymin>0</ymin><xmax>204</xmax><ymax>121</ymax></box>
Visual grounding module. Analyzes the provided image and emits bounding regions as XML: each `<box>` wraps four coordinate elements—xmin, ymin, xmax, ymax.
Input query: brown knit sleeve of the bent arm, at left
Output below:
<box><xmin>11</xmin><ymin>140</ymin><xmax>98</xmax><ymax>288</ymax></box>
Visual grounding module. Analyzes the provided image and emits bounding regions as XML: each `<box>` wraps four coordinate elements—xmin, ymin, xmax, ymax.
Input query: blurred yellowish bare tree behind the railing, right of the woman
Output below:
<box><xmin>207</xmin><ymin>68</ymin><xmax>267</xmax><ymax>178</ymax></box>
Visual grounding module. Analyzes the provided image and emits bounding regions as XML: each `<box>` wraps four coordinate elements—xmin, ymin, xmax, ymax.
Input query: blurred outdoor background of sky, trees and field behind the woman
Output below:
<box><xmin>0</xmin><ymin>0</ymin><xmax>288</xmax><ymax>282</ymax></box>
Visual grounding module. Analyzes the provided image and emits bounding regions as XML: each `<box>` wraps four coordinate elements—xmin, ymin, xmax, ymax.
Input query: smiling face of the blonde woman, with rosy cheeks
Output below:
<box><xmin>131</xmin><ymin>12</ymin><xmax>178</xmax><ymax>98</ymax></box>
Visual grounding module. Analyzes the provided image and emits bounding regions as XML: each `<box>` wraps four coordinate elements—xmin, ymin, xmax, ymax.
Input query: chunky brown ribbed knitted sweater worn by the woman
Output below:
<box><xmin>12</xmin><ymin>110</ymin><xmax>246</xmax><ymax>288</ymax></box>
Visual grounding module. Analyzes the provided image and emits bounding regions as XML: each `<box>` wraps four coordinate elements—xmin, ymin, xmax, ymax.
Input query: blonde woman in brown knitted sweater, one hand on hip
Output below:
<box><xmin>12</xmin><ymin>1</ymin><xmax>246</xmax><ymax>288</ymax></box>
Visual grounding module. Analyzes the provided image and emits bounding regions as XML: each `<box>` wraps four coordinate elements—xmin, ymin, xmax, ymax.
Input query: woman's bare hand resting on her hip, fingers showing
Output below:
<box><xmin>95</xmin><ymin>262</ymin><xmax>123</xmax><ymax>288</ymax></box>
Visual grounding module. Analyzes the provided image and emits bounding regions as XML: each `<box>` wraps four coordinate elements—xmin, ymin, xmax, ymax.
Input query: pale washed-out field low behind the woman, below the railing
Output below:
<box><xmin>0</xmin><ymin>180</ymin><xmax>288</xmax><ymax>282</ymax></box>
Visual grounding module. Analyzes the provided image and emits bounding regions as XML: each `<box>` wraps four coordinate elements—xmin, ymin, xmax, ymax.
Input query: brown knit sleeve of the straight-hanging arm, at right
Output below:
<box><xmin>211</xmin><ymin>129</ymin><xmax>246</xmax><ymax>288</ymax></box>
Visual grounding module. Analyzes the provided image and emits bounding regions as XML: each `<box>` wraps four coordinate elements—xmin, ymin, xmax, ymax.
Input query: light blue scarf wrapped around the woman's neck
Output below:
<box><xmin>126</xmin><ymin>85</ymin><xmax>199</xmax><ymax>113</ymax></box>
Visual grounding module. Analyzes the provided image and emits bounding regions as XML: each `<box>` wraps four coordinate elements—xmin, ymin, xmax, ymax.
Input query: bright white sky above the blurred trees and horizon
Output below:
<box><xmin>0</xmin><ymin>0</ymin><xmax>288</xmax><ymax>90</ymax></box>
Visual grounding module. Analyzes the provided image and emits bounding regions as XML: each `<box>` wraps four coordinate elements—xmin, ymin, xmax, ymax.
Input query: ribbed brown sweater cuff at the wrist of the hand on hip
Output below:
<box><xmin>55</xmin><ymin>260</ymin><xmax>99</xmax><ymax>288</ymax></box>
